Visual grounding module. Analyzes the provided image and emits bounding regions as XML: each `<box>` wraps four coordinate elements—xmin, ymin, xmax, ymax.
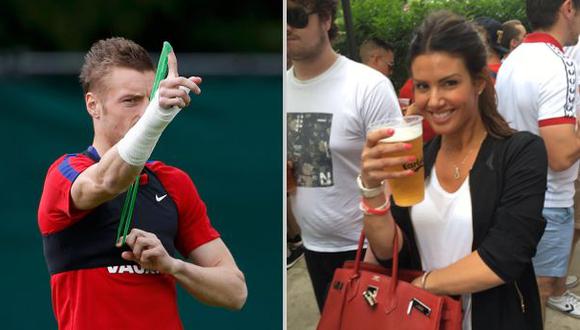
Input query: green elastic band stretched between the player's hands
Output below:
<box><xmin>115</xmin><ymin>41</ymin><xmax>173</xmax><ymax>246</ymax></box>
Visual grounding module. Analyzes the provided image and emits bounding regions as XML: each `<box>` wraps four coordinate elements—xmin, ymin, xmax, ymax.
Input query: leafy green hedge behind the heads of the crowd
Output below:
<box><xmin>335</xmin><ymin>0</ymin><xmax>529</xmax><ymax>90</ymax></box>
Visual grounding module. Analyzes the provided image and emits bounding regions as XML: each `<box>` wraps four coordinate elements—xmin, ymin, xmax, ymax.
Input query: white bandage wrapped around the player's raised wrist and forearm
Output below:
<box><xmin>117</xmin><ymin>90</ymin><xmax>189</xmax><ymax>166</ymax></box>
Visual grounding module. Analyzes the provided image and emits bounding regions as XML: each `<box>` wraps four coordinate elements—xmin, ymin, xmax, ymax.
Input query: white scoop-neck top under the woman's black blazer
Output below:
<box><xmin>411</xmin><ymin>170</ymin><xmax>473</xmax><ymax>330</ymax></box>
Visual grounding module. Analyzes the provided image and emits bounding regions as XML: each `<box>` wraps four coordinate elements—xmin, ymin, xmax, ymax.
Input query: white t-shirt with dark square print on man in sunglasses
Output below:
<box><xmin>286</xmin><ymin>56</ymin><xmax>401</xmax><ymax>252</ymax></box>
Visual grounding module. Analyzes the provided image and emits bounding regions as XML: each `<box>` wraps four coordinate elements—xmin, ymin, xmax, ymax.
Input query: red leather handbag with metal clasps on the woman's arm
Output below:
<box><xmin>317</xmin><ymin>227</ymin><xmax>462</xmax><ymax>330</ymax></box>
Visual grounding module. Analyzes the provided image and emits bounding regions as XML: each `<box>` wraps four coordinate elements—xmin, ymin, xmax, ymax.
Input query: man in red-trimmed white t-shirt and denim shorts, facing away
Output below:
<box><xmin>496</xmin><ymin>0</ymin><xmax>580</xmax><ymax>317</ymax></box>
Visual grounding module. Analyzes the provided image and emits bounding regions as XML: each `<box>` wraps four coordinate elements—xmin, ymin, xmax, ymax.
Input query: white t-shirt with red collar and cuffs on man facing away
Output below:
<box><xmin>495</xmin><ymin>42</ymin><xmax>578</xmax><ymax>207</ymax></box>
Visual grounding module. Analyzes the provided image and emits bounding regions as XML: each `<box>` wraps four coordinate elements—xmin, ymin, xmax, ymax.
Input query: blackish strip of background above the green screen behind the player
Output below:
<box><xmin>0</xmin><ymin>0</ymin><xmax>282</xmax><ymax>53</ymax></box>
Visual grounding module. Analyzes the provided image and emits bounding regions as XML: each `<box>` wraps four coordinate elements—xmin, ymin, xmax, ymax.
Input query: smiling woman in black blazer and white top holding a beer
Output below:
<box><xmin>360</xmin><ymin>12</ymin><xmax>547</xmax><ymax>330</ymax></box>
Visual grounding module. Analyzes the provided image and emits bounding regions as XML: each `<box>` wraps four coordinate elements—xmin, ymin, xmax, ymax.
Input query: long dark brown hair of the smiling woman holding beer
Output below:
<box><xmin>409</xmin><ymin>11</ymin><xmax>514</xmax><ymax>138</ymax></box>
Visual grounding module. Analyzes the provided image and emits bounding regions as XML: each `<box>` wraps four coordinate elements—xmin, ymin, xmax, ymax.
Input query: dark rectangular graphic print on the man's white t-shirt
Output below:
<box><xmin>288</xmin><ymin>112</ymin><xmax>334</xmax><ymax>187</ymax></box>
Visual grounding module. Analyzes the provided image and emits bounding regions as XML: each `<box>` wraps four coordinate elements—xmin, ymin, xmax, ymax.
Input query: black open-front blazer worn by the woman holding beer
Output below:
<box><xmin>381</xmin><ymin>132</ymin><xmax>548</xmax><ymax>330</ymax></box>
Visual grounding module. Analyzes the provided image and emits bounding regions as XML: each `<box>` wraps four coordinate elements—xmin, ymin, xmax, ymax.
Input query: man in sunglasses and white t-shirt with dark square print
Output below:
<box><xmin>286</xmin><ymin>0</ymin><xmax>401</xmax><ymax>310</ymax></box>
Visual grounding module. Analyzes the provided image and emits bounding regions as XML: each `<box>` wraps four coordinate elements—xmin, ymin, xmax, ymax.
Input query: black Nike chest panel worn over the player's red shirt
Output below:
<box><xmin>43</xmin><ymin>149</ymin><xmax>178</xmax><ymax>275</ymax></box>
